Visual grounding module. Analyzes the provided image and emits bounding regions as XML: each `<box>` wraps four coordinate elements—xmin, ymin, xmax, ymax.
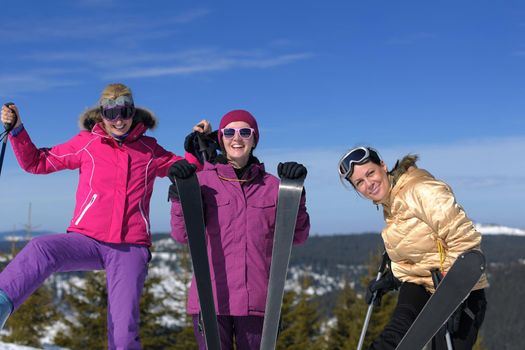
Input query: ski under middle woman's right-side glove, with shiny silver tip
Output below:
<box><xmin>261</xmin><ymin>178</ymin><xmax>304</xmax><ymax>350</ymax></box>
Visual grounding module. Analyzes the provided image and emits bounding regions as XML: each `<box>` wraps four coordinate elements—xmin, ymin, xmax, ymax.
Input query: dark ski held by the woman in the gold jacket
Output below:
<box><xmin>396</xmin><ymin>250</ymin><xmax>485</xmax><ymax>350</ymax></box>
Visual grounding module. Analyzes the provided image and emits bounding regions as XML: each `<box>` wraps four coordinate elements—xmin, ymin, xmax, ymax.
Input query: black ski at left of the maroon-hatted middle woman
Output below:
<box><xmin>176</xmin><ymin>174</ymin><xmax>221</xmax><ymax>350</ymax></box>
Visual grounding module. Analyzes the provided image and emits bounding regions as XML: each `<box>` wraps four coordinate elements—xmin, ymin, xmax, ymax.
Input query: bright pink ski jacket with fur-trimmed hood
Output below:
<box><xmin>10</xmin><ymin>109</ymin><xmax>198</xmax><ymax>246</ymax></box>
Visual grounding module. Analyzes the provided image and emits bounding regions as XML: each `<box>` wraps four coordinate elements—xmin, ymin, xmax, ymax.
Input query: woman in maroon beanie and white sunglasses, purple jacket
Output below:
<box><xmin>170</xmin><ymin>110</ymin><xmax>310</xmax><ymax>350</ymax></box>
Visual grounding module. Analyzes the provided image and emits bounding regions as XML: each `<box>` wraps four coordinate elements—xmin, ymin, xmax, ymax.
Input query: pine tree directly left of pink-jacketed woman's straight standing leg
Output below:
<box><xmin>54</xmin><ymin>271</ymin><xmax>107</xmax><ymax>350</ymax></box>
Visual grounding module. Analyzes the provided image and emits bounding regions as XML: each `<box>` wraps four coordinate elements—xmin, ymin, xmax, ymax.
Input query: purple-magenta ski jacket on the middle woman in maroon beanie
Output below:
<box><xmin>171</xmin><ymin>163</ymin><xmax>310</xmax><ymax>316</ymax></box>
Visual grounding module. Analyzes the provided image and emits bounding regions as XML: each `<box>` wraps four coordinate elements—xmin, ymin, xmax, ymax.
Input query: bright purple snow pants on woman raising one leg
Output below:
<box><xmin>0</xmin><ymin>233</ymin><xmax>150</xmax><ymax>350</ymax></box>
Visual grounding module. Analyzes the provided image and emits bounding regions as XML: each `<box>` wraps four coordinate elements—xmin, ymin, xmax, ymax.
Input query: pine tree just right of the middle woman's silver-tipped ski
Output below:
<box><xmin>277</xmin><ymin>278</ymin><xmax>322</xmax><ymax>350</ymax></box>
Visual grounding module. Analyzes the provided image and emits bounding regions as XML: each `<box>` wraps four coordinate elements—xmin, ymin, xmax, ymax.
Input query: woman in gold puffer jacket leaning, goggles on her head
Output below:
<box><xmin>339</xmin><ymin>147</ymin><xmax>488</xmax><ymax>350</ymax></box>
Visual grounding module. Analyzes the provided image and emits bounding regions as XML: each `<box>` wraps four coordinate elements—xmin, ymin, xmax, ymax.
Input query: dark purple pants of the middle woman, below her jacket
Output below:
<box><xmin>192</xmin><ymin>315</ymin><xmax>264</xmax><ymax>350</ymax></box>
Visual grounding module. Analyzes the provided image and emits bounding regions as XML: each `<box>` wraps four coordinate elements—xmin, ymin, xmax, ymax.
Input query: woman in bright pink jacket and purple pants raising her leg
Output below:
<box><xmin>0</xmin><ymin>84</ymin><xmax>198</xmax><ymax>349</ymax></box>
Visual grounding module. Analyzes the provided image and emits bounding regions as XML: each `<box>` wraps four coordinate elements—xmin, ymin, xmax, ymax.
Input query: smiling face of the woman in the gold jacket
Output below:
<box><xmin>350</xmin><ymin>162</ymin><xmax>390</xmax><ymax>202</ymax></box>
